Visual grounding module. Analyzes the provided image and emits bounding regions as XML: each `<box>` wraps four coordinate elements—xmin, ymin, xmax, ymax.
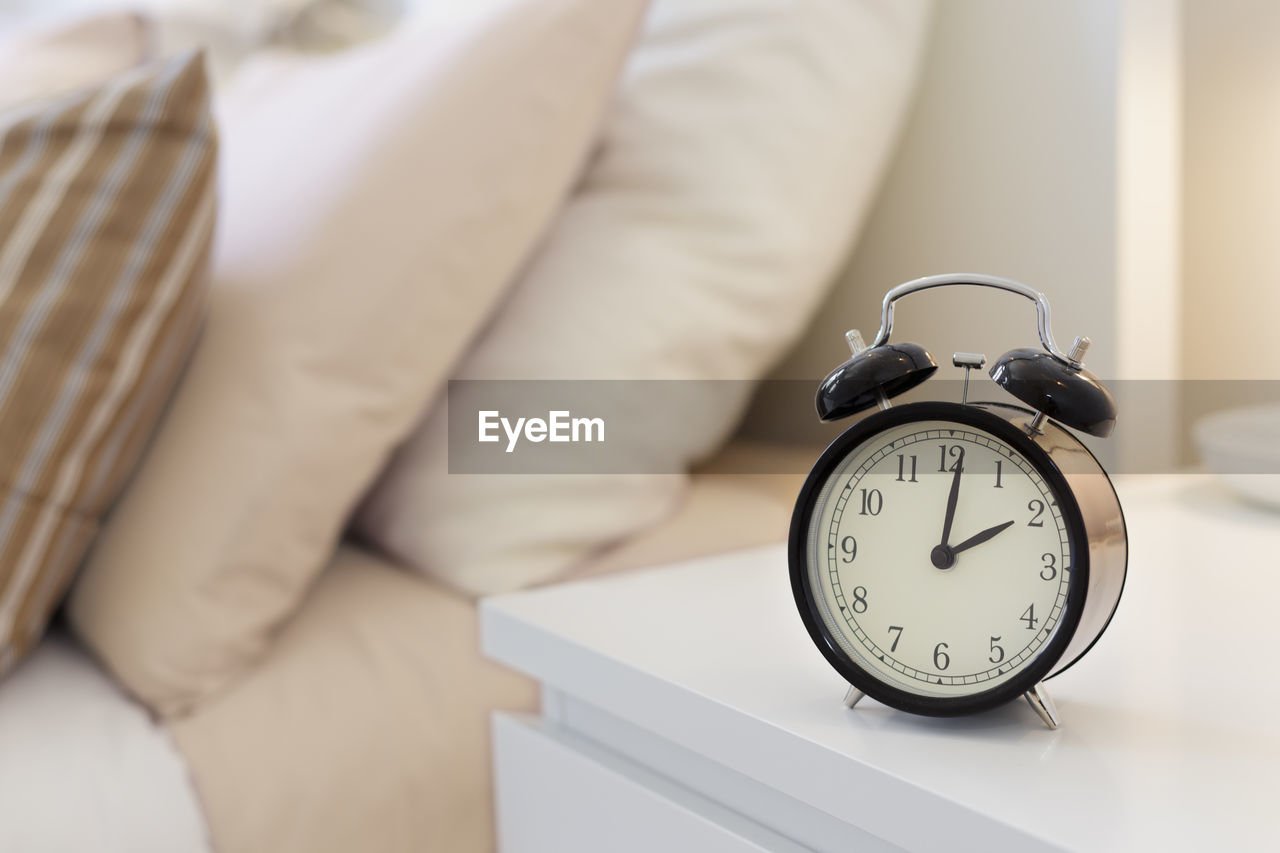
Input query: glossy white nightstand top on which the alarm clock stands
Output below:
<box><xmin>483</xmin><ymin>475</ymin><xmax>1280</xmax><ymax>850</ymax></box>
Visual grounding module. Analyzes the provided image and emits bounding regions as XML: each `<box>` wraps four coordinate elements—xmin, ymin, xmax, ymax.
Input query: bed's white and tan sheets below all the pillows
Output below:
<box><xmin>0</xmin><ymin>443</ymin><xmax>810</xmax><ymax>853</ymax></box>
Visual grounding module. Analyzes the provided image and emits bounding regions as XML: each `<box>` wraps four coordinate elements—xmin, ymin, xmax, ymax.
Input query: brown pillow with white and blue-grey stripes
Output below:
<box><xmin>0</xmin><ymin>54</ymin><xmax>215</xmax><ymax>675</ymax></box>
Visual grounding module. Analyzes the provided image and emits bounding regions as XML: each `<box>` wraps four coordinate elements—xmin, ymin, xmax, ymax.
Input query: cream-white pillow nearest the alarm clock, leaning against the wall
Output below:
<box><xmin>357</xmin><ymin>0</ymin><xmax>927</xmax><ymax>594</ymax></box>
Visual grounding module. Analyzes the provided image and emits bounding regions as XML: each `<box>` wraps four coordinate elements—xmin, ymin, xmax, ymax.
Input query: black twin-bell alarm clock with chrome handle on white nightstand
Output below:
<box><xmin>788</xmin><ymin>274</ymin><xmax>1129</xmax><ymax>729</ymax></box>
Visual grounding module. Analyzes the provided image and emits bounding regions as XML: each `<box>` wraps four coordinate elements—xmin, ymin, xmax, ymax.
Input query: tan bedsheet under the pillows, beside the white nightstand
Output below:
<box><xmin>172</xmin><ymin>448</ymin><xmax>818</xmax><ymax>853</ymax></box>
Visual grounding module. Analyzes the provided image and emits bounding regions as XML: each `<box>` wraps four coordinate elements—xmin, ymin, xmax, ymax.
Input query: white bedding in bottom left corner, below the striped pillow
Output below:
<box><xmin>0</xmin><ymin>630</ymin><xmax>210</xmax><ymax>853</ymax></box>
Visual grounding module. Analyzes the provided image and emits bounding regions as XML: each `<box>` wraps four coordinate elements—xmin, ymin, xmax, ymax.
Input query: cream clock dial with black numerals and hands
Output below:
<box><xmin>806</xmin><ymin>420</ymin><xmax>1073</xmax><ymax>697</ymax></box>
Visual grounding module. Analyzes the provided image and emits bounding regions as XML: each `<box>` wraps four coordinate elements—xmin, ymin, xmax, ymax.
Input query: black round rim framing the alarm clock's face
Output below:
<box><xmin>787</xmin><ymin>401</ymin><xmax>1089</xmax><ymax>717</ymax></box>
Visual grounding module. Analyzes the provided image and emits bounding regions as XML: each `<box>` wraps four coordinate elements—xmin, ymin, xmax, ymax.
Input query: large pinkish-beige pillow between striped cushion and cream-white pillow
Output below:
<box><xmin>69</xmin><ymin>0</ymin><xmax>643</xmax><ymax>716</ymax></box>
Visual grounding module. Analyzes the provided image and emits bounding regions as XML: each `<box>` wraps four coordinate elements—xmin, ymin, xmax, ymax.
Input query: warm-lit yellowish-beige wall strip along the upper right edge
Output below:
<box><xmin>1183</xmin><ymin>0</ymin><xmax>1280</xmax><ymax>379</ymax></box>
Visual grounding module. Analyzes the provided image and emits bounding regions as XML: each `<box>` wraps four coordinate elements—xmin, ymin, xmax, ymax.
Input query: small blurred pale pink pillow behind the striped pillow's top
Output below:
<box><xmin>0</xmin><ymin>13</ymin><xmax>150</xmax><ymax>109</ymax></box>
